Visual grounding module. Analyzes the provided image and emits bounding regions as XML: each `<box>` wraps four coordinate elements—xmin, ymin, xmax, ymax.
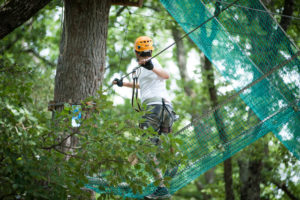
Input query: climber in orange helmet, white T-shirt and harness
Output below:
<box><xmin>113</xmin><ymin>36</ymin><xmax>175</xmax><ymax>199</ymax></box>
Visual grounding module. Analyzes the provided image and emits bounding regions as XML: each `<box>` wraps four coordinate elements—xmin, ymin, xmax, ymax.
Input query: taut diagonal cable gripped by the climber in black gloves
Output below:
<box><xmin>107</xmin><ymin>0</ymin><xmax>239</xmax><ymax>90</ymax></box>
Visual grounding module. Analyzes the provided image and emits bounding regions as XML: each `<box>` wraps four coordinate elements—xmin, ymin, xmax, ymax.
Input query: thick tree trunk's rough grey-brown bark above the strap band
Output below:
<box><xmin>54</xmin><ymin>0</ymin><xmax>111</xmax><ymax>103</ymax></box>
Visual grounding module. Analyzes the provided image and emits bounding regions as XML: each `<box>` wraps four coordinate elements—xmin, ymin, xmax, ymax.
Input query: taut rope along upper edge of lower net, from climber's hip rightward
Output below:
<box><xmin>175</xmin><ymin>51</ymin><xmax>300</xmax><ymax>135</ymax></box>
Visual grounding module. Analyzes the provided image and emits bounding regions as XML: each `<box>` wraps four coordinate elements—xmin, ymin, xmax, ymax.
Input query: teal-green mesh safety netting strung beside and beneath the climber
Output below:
<box><xmin>86</xmin><ymin>0</ymin><xmax>300</xmax><ymax>199</ymax></box>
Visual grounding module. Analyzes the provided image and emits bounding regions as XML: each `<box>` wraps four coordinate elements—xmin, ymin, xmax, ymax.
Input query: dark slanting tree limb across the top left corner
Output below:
<box><xmin>0</xmin><ymin>0</ymin><xmax>51</xmax><ymax>39</ymax></box>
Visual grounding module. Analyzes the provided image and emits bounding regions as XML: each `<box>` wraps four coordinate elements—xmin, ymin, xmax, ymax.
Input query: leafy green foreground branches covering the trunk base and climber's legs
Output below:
<box><xmin>0</xmin><ymin>61</ymin><xmax>183</xmax><ymax>199</ymax></box>
